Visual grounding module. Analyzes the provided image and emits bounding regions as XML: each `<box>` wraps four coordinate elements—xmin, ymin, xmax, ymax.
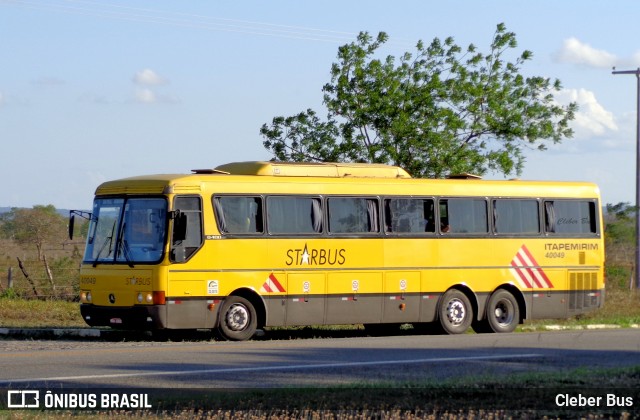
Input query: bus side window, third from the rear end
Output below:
<box><xmin>439</xmin><ymin>198</ymin><xmax>489</xmax><ymax>234</ymax></box>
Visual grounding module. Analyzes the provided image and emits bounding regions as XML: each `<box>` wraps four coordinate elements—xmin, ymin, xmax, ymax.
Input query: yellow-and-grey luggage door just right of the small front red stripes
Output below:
<box><xmin>286</xmin><ymin>273</ymin><xmax>326</xmax><ymax>325</ymax></box>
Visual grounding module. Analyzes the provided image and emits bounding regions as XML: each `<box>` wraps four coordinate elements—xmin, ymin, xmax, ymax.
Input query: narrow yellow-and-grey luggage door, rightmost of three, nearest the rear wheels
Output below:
<box><xmin>382</xmin><ymin>271</ymin><xmax>420</xmax><ymax>323</ymax></box>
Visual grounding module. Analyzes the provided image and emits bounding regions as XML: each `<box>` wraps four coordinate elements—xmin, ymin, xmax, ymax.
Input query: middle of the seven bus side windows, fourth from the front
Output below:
<box><xmin>385</xmin><ymin>198</ymin><xmax>435</xmax><ymax>233</ymax></box>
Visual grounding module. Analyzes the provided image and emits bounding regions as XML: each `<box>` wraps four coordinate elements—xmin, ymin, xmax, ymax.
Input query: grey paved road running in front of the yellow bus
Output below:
<box><xmin>0</xmin><ymin>329</ymin><xmax>640</xmax><ymax>388</ymax></box>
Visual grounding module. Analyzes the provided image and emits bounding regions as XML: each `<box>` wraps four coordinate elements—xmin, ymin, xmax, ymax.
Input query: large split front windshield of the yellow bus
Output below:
<box><xmin>84</xmin><ymin>198</ymin><xmax>167</xmax><ymax>266</ymax></box>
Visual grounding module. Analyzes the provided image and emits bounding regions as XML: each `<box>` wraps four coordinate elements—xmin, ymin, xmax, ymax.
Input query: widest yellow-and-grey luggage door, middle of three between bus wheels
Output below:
<box><xmin>326</xmin><ymin>272</ymin><xmax>382</xmax><ymax>324</ymax></box>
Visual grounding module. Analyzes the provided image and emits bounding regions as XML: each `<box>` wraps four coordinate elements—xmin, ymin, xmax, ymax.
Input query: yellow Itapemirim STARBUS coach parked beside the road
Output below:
<box><xmin>70</xmin><ymin>162</ymin><xmax>605</xmax><ymax>340</ymax></box>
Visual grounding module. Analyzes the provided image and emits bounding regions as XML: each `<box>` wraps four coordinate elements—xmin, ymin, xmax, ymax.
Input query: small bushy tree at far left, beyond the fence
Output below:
<box><xmin>2</xmin><ymin>205</ymin><xmax>66</xmax><ymax>260</ymax></box>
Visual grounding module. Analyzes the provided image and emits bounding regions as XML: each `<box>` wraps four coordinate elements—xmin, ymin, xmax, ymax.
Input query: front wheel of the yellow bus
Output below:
<box><xmin>218</xmin><ymin>296</ymin><xmax>258</xmax><ymax>341</ymax></box>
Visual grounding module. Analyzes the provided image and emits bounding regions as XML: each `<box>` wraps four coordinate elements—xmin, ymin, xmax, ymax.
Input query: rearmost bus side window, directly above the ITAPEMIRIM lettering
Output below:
<box><xmin>544</xmin><ymin>200</ymin><xmax>598</xmax><ymax>236</ymax></box>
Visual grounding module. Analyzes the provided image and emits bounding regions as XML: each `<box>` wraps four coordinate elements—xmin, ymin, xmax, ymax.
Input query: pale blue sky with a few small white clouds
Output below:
<box><xmin>0</xmin><ymin>0</ymin><xmax>640</xmax><ymax>209</ymax></box>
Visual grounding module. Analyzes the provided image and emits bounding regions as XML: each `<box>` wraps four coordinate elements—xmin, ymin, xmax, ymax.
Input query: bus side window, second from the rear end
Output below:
<box><xmin>493</xmin><ymin>199</ymin><xmax>540</xmax><ymax>235</ymax></box>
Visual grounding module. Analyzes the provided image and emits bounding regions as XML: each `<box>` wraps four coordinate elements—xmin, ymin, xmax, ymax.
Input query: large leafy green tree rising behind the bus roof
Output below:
<box><xmin>260</xmin><ymin>24</ymin><xmax>577</xmax><ymax>178</ymax></box>
